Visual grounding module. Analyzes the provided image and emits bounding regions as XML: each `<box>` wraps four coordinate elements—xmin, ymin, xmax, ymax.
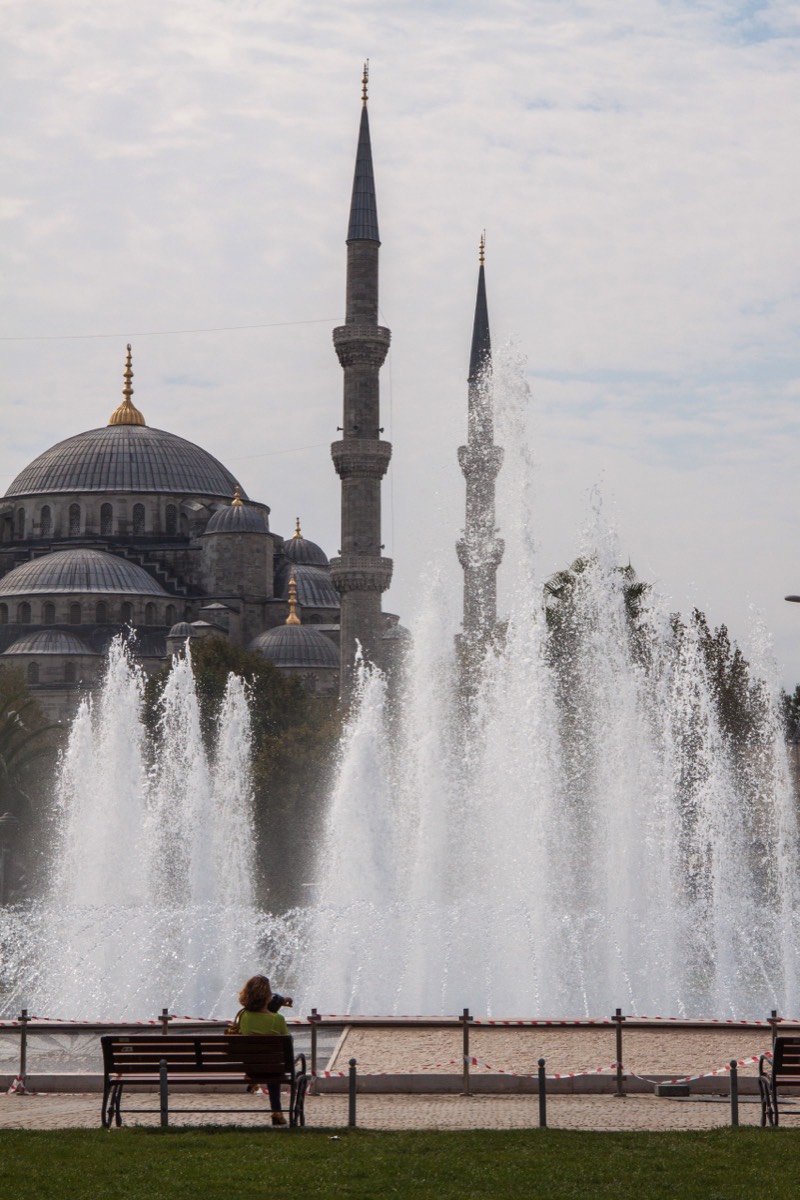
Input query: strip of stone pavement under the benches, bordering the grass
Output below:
<box><xmin>0</xmin><ymin>1093</ymin><xmax>782</xmax><ymax>1133</ymax></box>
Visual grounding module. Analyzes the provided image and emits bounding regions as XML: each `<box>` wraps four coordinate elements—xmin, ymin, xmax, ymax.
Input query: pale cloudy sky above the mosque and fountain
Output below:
<box><xmin>0</xmin><ymin>0</ymin><xmax>800</xmax><ymax>688</ymax></box>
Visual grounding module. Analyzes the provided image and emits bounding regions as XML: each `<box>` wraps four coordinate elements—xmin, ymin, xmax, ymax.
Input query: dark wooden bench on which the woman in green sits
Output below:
<box><xmin>100</xmin><ymin>1033</ymin><xmax>308</xmax><ymax>1129</ymax></box>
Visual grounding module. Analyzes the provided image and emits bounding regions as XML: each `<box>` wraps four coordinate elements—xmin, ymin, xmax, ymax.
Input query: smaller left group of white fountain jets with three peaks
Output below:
<box><xmin>4</xmin><ymin>638</ymin><xmax>298</xmax><ymax>1020</ymax></box>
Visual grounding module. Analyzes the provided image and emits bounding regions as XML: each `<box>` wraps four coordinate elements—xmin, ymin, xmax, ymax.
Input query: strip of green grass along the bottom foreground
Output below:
<box><xmin>0</xmin><ymin>1129</ymin><xmax>800</xmax><ymax>1200</ymax></box>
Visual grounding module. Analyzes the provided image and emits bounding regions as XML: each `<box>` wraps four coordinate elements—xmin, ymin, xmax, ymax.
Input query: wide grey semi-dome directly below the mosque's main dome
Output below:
<box><xmin>0</xmin><ymin>548</ymin><xmax>167</xmax><ymax>596</ymax></box>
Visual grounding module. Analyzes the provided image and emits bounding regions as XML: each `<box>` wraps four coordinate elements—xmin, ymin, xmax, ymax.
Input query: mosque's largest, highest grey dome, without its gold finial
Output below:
<box><xmin>6</xmin><ymin>425</ymin><xmax>247</xmax><ymax>500</ymax></box>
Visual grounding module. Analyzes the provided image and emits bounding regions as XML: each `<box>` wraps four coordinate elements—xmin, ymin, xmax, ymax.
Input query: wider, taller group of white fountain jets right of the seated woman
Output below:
<box><xmin>305</xmin><ymin>350</ymin><xmax>800</xmax><ymax>1018</ymax></box>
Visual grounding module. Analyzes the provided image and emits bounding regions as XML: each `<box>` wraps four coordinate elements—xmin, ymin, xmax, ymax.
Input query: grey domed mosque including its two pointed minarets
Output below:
<box><xmin>0</xmin><ymin>68</ymin><xmax>501</xmax><ymax>720</ymax></box>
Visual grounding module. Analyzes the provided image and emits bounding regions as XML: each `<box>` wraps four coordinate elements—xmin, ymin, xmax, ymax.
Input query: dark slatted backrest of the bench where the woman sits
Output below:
<box><xmin>101</xmin><ymin>1033</ymin><xmax>294</xmax><ymax>1081</ymax></box>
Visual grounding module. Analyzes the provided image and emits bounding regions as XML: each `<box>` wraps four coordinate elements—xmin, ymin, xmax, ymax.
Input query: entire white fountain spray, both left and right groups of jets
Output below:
<box><xmin>0</xmin><ymin>362</ymin><xmax>800</xmax><ymax>1020</ymax></box>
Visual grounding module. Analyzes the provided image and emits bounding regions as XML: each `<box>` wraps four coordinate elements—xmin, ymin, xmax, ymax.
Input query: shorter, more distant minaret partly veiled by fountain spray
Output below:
<box><xmin>456</xmin><ymin>236</ymin><xmax>504</xmax><ymax>643</ymax></box>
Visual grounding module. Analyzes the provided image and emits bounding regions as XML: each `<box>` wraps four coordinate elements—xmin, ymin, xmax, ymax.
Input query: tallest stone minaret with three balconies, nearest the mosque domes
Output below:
<box><xmin>331</xmin><ymin>64</ymin><xmax>392</xmax><ymax>700</ymax></box>
